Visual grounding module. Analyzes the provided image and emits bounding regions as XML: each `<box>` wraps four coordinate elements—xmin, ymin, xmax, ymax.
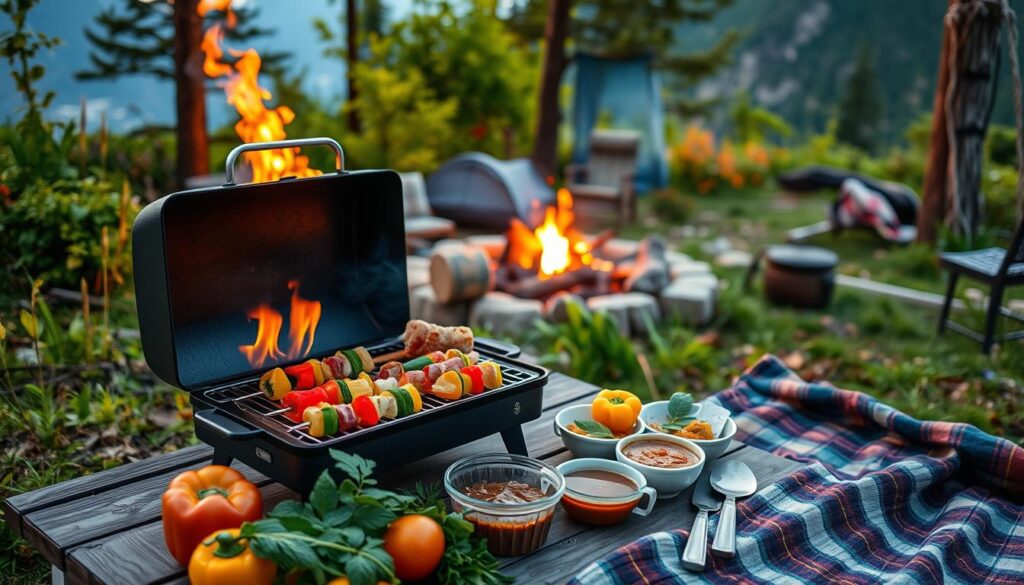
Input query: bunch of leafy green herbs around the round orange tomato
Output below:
<box><xmin>237</xmin><ymin>451</ymin><xmax>511</xmax><ymax>585</ymax></box>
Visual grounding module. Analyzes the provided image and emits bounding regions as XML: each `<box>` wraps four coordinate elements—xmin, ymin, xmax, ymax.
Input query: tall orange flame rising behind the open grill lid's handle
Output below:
<box><xmin>197</xmin><ymin>0</ymin><xmax>321</xmax><ymax>182</ymax></box>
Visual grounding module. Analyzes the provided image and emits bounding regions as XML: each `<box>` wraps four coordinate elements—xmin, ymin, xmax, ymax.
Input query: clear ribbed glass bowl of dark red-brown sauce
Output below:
<box><xmin>444</xmin><ymin>453</ymin><xmax>565</xmax><ymax>556</ymax></box>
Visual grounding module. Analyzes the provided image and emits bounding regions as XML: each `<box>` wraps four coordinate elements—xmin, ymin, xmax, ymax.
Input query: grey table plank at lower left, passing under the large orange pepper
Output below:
<box><xmin>66</xmin><ymin>484</ymin><xmax>298</xmax><ymax>585</ymax></box>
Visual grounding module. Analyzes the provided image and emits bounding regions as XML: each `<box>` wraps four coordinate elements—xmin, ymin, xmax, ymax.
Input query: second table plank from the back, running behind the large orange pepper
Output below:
<box><xmin>24</xmin><ymin>460</ymin><xmax>270</xmax><ymax>570</ymax></box>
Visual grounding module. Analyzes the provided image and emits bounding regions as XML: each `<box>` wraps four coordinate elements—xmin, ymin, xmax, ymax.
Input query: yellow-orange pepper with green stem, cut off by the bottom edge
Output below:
<box><xmin>188</xmin><ymin>529</ymin><xmax>278</xmax><ymax>585</ymax></box>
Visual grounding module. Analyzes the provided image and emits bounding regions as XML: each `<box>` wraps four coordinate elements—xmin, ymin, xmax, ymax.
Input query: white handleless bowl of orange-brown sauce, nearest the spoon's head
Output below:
<box><xmin>615</xmin><ymin>433</ymin><xmax>707</xmax><ymax>498</ymax></box>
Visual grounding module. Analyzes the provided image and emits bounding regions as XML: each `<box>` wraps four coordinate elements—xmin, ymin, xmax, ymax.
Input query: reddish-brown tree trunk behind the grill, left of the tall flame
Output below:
<box><xmin>174</xmin><ymin>0</ymin><xmax>210</xmax><ymax>186</ymax></box>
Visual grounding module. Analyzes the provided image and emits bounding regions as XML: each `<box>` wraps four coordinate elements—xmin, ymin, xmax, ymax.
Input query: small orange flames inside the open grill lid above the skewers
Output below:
<box><xmin>239</xmin><ymin>281</ymin><xmax>322</xmax><ymax>368</ymax></box>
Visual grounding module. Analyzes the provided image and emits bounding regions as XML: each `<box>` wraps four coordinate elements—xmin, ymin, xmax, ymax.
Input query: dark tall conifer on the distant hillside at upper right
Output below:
<box><xmin>836</xmin><ymin>45</ymin><xmax>882</xmax><ymax>153</ymax></box>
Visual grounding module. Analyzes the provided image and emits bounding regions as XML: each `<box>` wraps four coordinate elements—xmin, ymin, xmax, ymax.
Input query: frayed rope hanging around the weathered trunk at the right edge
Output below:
<box><xmin>943</xmin><ymin>0</ymin><xmax>1024</xmax><ymax>233</ymax></box>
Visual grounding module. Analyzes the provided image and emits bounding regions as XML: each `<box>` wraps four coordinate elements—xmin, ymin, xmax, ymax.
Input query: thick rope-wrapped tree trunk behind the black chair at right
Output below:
<box><xmin>918</xmin><ymin>0</ymin><xmax>1001</xmax><ymax>243</ymax></box>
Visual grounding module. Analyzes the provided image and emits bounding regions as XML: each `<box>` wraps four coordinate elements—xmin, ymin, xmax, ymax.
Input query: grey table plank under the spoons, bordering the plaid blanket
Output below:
<box><xmin>504</xmin><ymin>447</ymin><xmax>803</xmax><ymax>584</ymax></box>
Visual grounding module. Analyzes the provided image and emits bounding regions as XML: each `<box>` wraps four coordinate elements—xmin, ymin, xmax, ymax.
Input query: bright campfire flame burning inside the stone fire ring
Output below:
<box><xmin>507</xmin><ymin>189</ymin><xmax>594</xmax><ymax>279</ymax></box>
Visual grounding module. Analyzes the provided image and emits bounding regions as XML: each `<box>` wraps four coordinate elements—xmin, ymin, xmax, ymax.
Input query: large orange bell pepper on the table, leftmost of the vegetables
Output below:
<box><xmin>163</xmin><ymin>465</ymin><xmax>263</xmax><ymax>566</ymax></box>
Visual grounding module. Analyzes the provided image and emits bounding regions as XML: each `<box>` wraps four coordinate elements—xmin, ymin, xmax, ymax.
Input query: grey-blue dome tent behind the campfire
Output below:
<box><xmin>427</xmin><ymin>153</ymin><xmax>555</xmax><ymax>229</ymax></box>
